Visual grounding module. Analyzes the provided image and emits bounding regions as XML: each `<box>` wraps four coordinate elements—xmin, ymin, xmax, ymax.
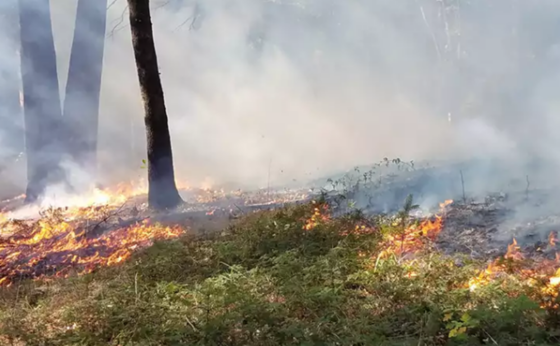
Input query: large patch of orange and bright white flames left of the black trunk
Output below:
<box><xmin>0</xmin><ymin>184</ymin><xmax>188</xmax><ymax>286</ymax></box>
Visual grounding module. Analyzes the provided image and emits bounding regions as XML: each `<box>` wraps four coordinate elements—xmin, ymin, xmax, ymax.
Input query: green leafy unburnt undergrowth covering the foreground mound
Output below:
<box><xmin>0</xmin><ymin>204</ymin><xmax>560</xmax><ymax>346</ymax></box>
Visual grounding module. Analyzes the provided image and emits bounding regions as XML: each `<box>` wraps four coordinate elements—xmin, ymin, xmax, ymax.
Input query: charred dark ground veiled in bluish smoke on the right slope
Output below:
<box><xmin>316</xmin><ymin>160</ymin><xmax>560</xmax><ymax>259</ymax></box>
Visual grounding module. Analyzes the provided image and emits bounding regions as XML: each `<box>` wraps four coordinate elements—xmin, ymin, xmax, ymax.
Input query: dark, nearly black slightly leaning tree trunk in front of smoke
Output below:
<box><xmin>128</xmin><ymin>0</ymin><xmax>182</xmax><ymax>209</ymax></box>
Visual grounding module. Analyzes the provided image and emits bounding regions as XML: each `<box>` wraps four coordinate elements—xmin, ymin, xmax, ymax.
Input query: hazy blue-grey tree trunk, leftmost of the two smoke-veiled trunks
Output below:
<box><xmin>19</xmin><ymin>0</ymin><xmax>64</xmax><ymax>202</ymax></box>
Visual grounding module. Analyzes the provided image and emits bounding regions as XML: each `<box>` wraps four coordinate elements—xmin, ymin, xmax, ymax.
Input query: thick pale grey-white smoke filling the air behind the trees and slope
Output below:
<box><xmin>0</xmin><ymin>0</ymin><xmax>560</xmax><ymax>203</ymax></box>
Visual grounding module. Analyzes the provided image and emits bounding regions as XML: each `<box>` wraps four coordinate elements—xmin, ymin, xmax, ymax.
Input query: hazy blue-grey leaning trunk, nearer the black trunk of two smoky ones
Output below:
<box><xmin>64</xmin><ymin>0</ymin><xmax>107</xmax><ymax>187</ymax></box>
